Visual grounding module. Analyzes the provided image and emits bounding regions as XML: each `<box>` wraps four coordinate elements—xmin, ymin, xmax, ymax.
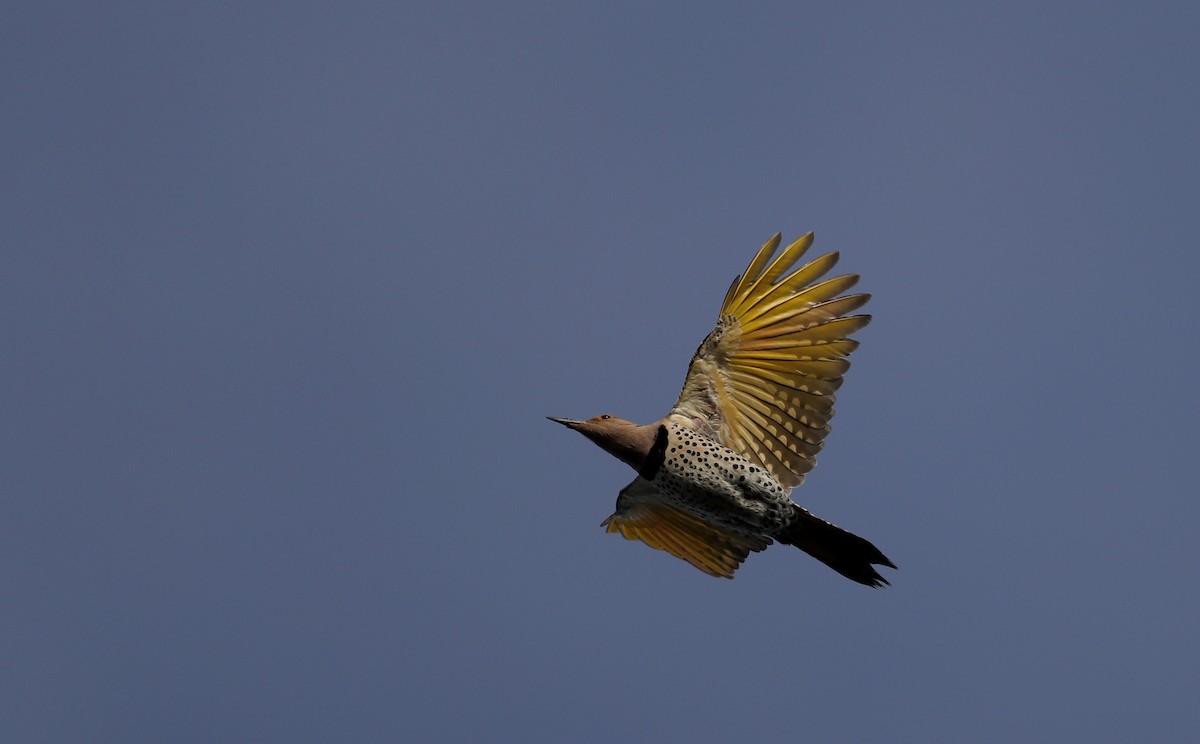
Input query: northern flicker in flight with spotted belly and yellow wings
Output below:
<box><xmin>550</xmin><ymin>233</ymin><xmax>895</xmax><ymax>587</ymax></box>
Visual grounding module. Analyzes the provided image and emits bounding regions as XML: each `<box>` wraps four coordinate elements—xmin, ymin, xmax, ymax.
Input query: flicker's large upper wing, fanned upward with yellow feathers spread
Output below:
<box><xmin>671</xmin><ymin>233</ymin><xmax>871</xmax><ymax>487</ymax></box>
